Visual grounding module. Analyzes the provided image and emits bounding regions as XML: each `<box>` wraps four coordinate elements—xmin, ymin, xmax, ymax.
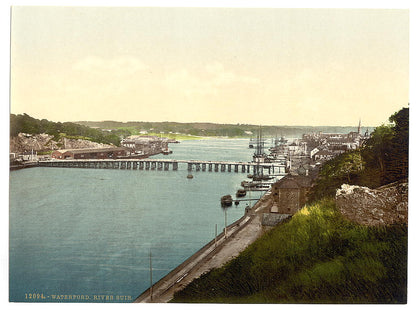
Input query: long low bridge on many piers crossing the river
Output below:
<box><xmin>38</xmin><ymin>158</ymin><xmax>285</xmax><ymax>175</ymax></box>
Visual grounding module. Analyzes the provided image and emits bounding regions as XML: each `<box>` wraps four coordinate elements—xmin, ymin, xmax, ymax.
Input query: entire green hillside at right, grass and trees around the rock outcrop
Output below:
<box><xmin>173</xmin><ymin>108</ymin><xmax>409</xmax><ymax>303</ymax></box>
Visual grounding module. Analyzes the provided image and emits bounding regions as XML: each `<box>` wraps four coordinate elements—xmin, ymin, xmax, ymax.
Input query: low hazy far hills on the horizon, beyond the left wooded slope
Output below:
<box><xmin>76</xmin><ymin>121</ymin><xmax>373</xmax><ymax>138</ymax></box>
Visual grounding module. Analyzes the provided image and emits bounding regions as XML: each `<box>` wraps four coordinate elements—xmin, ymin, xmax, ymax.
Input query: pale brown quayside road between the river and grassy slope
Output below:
<box><xmin>134</xmin><ymin>191</ymin><xmax>272</xmax><ymax>303</ymax></box>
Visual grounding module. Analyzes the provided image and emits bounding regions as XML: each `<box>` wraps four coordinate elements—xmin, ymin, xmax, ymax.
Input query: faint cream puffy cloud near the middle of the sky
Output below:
<box><xmin>165</xmin><ymin>62</ymin><xmax>260</xmax><ymax>96</ymax></box>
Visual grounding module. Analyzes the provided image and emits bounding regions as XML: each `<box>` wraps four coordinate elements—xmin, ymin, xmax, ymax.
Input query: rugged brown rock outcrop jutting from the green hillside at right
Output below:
<box><xmin>336</xmin><ymin>182</ymin><xmax>408</xmax><ymax>226</ymax></box>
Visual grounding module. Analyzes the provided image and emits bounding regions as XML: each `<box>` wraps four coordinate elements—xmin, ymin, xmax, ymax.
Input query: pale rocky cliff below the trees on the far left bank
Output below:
<box><xmin>10</xmin><ymin>133</ymin><xmax>113</xmax><ymax>153</ymax></box>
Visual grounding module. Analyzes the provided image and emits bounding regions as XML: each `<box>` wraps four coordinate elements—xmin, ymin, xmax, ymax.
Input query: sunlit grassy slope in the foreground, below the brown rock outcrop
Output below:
<box><xmin>173</xmin><ymin>199</ymin><xmax>407</xmax><ymax>303</ymax></box>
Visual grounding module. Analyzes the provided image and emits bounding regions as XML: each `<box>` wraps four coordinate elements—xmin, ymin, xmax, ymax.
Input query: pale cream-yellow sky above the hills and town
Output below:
<box><xmin>10</xmin><ymin>6</ymin><xmax>409</xmax><ymax>126</ymax></box>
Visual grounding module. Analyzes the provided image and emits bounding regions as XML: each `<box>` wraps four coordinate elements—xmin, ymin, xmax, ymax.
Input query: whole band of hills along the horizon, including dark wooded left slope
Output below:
<box><xmin>10</xmin><ymin>113</ymin><xmax>373</xmax><ymax>145</ymax></box>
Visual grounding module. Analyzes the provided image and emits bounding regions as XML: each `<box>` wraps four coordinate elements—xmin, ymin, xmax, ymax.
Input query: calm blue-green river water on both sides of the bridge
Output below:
<box><xmin>10</xmin><ymin>139</ymin><xmax>266</xmax><ymax>302</ymax></box>
